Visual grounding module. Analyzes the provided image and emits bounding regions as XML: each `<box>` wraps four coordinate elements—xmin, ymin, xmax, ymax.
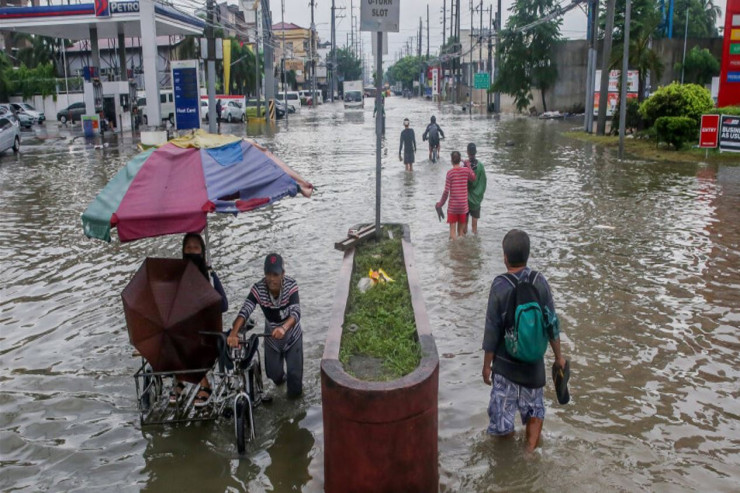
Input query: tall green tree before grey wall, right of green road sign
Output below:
<box><xmin>492</xmin><ymin>0</ymin><xmax>562</xmax><ymax>111</ymax></box>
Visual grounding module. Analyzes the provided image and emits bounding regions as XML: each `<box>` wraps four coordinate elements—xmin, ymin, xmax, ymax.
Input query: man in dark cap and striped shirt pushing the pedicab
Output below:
<box><xmin>226</xmin><ymin>253</ymin><xmax>303</xmax><ymax>397</ymax></box>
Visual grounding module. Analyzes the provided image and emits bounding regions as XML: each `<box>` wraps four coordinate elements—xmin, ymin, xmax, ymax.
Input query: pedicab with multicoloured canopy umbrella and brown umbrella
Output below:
<box><xmin>82</xmin><ymin>131</ymin><xmax>313</xmax><ymax>453</ymax></box>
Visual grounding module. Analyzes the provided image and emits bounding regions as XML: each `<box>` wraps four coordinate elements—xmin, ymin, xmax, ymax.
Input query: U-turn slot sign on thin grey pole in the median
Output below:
<box><xmin>360</xmin><ymin>0</ymin><xmax>401</xmax><ymax>239</ymax></box>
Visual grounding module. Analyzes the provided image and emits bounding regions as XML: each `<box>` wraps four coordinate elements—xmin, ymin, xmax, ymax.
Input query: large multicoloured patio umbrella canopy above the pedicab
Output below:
<box><xmin>82</xmin><ymin>133</ymin><xmax>313</xmax><ymax>242</ymax></box>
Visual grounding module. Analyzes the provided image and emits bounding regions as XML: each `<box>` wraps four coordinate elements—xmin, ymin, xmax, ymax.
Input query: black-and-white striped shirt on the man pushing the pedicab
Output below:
<box><xmin>237</xmin><ymin>276</ymin><xmax>303</xmax><ymax>351</ymax></box>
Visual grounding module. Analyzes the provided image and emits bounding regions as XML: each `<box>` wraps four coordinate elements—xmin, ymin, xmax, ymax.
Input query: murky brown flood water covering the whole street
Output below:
<box><xmin>0</xmin><ymin>98</ymin><xmax>740</xmax><ymax>492</ymax></box>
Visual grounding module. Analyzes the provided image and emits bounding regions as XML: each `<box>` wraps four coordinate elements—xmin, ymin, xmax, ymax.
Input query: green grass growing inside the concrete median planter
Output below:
<box><xmin>339</xmin><ymin>227</ymin><xmax>421</xmax><ymax>381</ymax></box>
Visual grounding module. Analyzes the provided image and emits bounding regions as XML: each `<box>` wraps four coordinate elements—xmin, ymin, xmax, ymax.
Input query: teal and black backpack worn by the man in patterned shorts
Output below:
<box><xmin>503</xmin><ymin>271</ymin><xmax>549</xmax><ymax>363</ymax></box>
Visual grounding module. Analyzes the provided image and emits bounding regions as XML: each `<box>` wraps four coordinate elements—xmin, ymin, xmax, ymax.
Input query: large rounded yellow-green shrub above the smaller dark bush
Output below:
<box><xmin>640</xmin><ymin>82</ymin><xmax>714</xmax><ymax>128</ymax></box>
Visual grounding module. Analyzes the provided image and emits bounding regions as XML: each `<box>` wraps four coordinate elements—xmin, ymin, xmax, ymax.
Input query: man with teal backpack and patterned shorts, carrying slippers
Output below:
<box><xmin>483</xmin><ymin>229</ymin><xmax>567</xmax><ymax>451</ymax></box>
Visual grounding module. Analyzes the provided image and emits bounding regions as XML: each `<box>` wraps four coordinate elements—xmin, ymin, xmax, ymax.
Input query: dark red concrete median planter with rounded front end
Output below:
<box><xmin>321</xmin><ymin>225</ymin><xmax>439</xmax><ymax>493</ymax></box>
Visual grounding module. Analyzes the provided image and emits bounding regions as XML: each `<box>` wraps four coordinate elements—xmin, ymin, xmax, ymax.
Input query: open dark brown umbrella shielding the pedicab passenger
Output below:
<box><xmin>121</xmin><ymin>258</ymin><xmax>222</xmax><ymax>383</ymax></box>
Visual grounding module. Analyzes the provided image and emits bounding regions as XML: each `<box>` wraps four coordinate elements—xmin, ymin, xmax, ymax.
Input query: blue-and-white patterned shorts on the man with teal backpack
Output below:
<box><xmin>486</xmin><ymin>374</ymin><xmax>545</xmax><ymax>435</ymax></box>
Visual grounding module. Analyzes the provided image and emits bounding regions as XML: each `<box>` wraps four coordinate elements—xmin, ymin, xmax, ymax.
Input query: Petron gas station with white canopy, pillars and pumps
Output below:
<box><xmin>0</xmin><ymin>0</ymin><xmax>205</xmax><ymax>131</ymax></box>
